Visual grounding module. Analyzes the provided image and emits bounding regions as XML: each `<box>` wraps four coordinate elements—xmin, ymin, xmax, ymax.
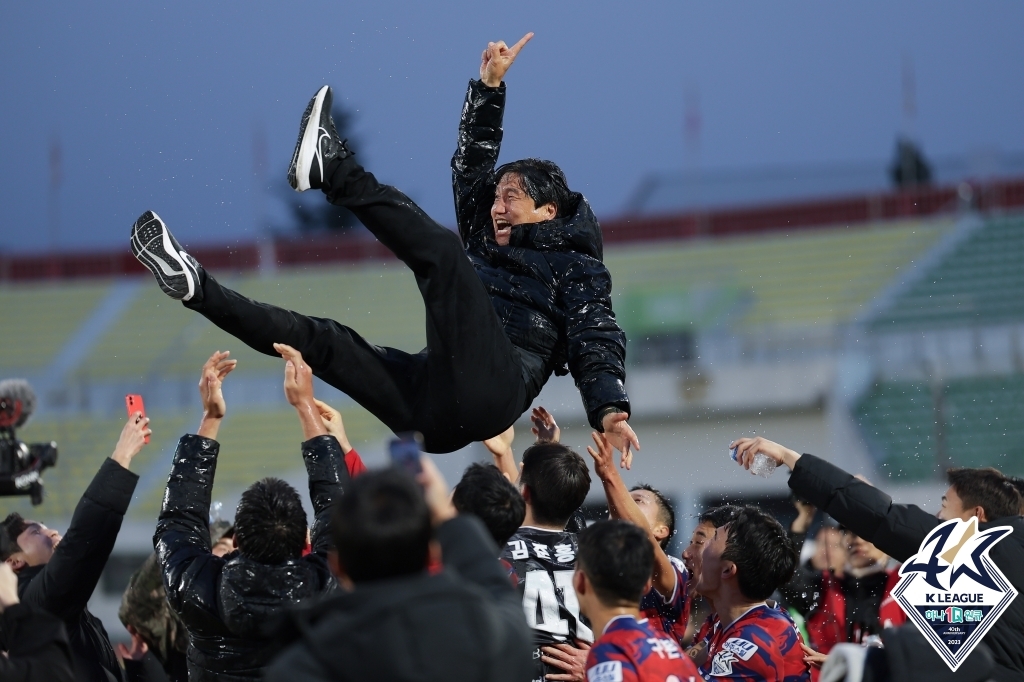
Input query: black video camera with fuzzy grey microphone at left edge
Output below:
<box><xmin>0</xmin><ymin>379</ymin><xmax>57</xmax><ymax>505</ymax></box>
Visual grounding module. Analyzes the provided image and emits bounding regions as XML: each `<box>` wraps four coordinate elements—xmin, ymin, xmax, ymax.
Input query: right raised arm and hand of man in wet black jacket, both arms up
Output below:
<box><xmin>273</xmin><ymin>343</ymin><xmax>351</xmax><ymax>557</ymax></box>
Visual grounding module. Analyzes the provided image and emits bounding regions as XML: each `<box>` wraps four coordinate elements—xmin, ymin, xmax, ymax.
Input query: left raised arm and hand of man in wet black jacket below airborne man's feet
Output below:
<box><xmin>153</xmin><ymin>351</ymin><xmax>237</xmax><ymax>612</ymax></box>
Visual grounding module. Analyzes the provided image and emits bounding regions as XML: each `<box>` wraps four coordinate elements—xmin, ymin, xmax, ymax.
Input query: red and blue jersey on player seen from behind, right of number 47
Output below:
<box><xmin>587</xmin><ymin>615</ymin><xmax>698</xmax><ymax>682</ymax></box>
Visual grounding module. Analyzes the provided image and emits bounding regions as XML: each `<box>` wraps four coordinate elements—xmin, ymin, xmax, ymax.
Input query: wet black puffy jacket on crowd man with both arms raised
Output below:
<box><xmin>154</xmin><ymin>435</ymin><xmax>349</xmax><ymax>682</ymax></box>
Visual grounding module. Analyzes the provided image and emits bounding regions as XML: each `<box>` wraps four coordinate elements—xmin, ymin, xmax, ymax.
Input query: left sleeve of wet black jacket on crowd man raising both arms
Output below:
<box><xmin>153</xmin><ymin>434</ymin><xmax>222</xmax><ymax>614</ymax></box>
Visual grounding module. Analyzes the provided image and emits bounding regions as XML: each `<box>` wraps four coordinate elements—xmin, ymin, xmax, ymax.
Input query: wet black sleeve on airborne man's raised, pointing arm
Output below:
<box><xmin>452</xmin><ymin>80</ymin><xmax>505</xmax><ymax>242</ymax></box>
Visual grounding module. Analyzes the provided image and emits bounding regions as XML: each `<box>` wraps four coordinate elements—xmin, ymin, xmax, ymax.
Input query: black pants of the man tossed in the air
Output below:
<box><xmin>185</xmin><ymin>158</ymin><xmax>530</xmax><ymax>453</ymax></box>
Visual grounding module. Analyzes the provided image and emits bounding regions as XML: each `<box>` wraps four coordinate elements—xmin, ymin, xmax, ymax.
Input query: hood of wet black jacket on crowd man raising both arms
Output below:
<box><xmin>218</xmin><ymin>555</ymin><xmax>324</xmax><ymax>637</ymax></box>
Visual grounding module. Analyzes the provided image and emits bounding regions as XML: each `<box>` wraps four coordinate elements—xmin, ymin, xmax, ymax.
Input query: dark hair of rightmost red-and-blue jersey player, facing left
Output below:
<box><xmin>720</xmin><ymin>507</ymin><xmax>800</xmax><ymax>601</ymax></box>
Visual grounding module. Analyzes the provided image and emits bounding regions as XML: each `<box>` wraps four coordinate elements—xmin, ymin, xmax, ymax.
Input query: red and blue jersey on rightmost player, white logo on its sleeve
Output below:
<box><xmin>700</xmin><ymin>604</ymin><xmax>811</xmax><ymax>682</ymax></box>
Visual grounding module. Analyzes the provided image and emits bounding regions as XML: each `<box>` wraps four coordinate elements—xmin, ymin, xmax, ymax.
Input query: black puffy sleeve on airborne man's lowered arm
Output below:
<box><xmin>558</xmin><ymin>257</ymin><xmax>630</xmax><ymax>431</ymax></box>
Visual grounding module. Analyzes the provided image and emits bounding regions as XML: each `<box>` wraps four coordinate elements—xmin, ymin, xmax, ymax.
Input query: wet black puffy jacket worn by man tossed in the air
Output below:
<box><xmin>452</xmin><ymin>81</ymin><xmax>630</xmax><ymax>430</ymax></box>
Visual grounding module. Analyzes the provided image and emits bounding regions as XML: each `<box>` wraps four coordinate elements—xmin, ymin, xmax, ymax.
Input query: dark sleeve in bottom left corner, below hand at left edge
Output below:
<box><xmin>0</xmin><ymin>604</ymin><xmax>75</xmax><ymax>682</ymax></box>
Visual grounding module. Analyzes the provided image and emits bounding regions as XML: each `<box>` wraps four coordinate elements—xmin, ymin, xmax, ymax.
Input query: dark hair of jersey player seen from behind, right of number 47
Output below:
<box><xmin>577</xmin><ymin>519</ymin><xmax>654</xmax><ymax>605</ymax></box>
